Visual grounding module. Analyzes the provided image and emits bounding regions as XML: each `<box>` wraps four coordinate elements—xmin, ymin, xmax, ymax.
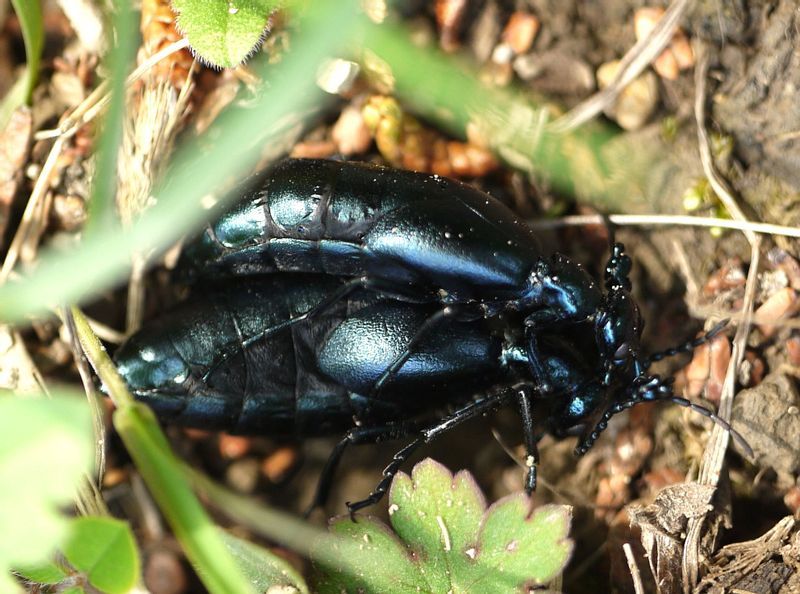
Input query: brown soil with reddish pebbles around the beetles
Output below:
<box><xmin>0</xmin><ymin>0</ymin><xmax>800</xmax><ymax>594</ymax></box>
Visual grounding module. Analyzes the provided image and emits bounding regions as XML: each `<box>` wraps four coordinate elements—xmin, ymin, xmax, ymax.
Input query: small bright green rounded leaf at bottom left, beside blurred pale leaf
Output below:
<box><xmin>63</xmin><ymin>517</ymin><xmax>139</xmax><ymax>594</ymax></box>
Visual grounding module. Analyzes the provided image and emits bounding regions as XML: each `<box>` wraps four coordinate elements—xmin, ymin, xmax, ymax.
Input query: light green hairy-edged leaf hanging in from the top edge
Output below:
<box><xmin>172</xmin><ymin>0</ymin><xmax>280</xmax><ymax>68</ymax></box>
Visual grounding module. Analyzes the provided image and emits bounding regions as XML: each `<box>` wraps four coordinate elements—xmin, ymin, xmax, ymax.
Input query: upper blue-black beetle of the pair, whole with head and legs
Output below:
<box><xmin>182</xmin><ymin>159</ymin><xmax>642</xmax><ymax>400</ymax></box>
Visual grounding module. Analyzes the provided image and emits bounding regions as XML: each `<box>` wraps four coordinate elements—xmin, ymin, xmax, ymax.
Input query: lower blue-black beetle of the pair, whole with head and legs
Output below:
<box><xmin>115</xmin><ymin>274</ymin><xmax>636</xmax><ymax>511</ymax></box>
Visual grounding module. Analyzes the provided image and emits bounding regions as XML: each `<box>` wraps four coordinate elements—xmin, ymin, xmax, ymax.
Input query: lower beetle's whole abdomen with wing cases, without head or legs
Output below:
<box><xmin>115</xmin><ymin>275</ymin><xmax>502</xmax><ymax>436</ymax></box>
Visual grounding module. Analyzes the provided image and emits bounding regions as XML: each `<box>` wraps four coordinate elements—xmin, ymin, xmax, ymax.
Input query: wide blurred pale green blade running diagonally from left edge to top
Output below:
<box><xmin>0</xmin><ymin>2</ymin><xmax>357</xmax><ymax>322</ymax></box>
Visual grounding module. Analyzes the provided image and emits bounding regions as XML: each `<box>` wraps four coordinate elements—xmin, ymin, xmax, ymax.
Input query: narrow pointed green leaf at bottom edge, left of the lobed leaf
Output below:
<box><xmin>222</xmin><ymin>532</ymin><xmax>308</xmax><ymax>594</ymax></box>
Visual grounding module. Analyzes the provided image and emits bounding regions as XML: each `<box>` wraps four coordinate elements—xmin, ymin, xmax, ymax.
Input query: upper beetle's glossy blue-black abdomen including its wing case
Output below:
<box><xmin>185</xmin><ymin>160</ymin><xmax>541</xmax><ymax>300</ymax></box>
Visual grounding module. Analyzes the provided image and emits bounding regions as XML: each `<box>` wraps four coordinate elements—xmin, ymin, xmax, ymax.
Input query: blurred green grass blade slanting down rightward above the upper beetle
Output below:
<box><xmin>365</xmin><ymin>24</ymin><xmax>666</xmax><ymax>211</ymax></box>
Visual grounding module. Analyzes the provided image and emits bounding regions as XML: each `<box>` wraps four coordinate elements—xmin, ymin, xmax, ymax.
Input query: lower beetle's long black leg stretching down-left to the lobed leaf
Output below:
<box><xmin>347</xmin><ymin>386</ymin><xmax>520</xmax><ymax>516</ymax></box>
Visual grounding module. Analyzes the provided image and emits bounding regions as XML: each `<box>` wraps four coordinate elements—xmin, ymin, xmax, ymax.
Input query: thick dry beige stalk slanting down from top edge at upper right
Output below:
<box><xmin>549</xmin><ymin>0</ymin><xmax>689</xmax><ymax>134</ymax></box>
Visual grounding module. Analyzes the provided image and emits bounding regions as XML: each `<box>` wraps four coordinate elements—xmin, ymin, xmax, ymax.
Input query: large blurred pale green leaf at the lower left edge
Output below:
<box><xmin>0</xmin><ymin>395</ymin><xmax>94</xmax><ymax>592</ymax></box>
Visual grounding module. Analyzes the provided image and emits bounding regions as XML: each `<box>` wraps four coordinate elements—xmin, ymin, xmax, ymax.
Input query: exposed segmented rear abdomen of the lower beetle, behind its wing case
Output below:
<box><xmin>115</xmin><ymin>277</ymin><xmax>352</xmax><ymax>435</ymax></box>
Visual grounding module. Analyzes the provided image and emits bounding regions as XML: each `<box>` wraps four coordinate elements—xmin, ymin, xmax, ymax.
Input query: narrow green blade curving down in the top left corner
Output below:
<box><xmin>0</xmin><ymin>0</ymin><xmax>44</xmax><ymax>129</ymax></box>
